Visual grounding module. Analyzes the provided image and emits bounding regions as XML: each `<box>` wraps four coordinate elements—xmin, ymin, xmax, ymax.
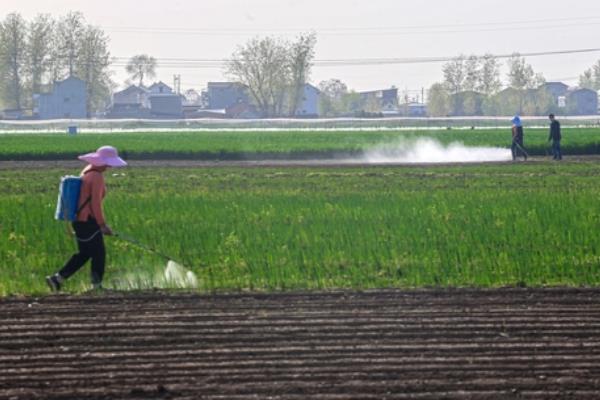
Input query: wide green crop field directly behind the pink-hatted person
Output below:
<box><xmin>0</xmin><ymin>163</ymin><xmax>600</xmax><ymax>295</ymax></box>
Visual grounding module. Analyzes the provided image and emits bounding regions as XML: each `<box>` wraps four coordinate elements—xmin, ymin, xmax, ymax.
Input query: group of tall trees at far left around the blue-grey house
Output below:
<box><xmin>0</xmin><ymin>12</ymin><xmax>113</xmax><ymax>116</ymax></box>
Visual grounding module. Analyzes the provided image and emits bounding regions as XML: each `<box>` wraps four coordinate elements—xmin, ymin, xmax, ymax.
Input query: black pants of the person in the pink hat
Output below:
<box><xmin>59</xmin><ymin>219</ymin><xmax>106</xmax><ymax>284</ymax></box>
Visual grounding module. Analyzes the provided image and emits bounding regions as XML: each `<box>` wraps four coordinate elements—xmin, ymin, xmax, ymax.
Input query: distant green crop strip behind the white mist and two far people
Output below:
<box><xmin>0</xmin><ymin>128</ymin><xmax>600</xmax><ymax>160</ymax></box>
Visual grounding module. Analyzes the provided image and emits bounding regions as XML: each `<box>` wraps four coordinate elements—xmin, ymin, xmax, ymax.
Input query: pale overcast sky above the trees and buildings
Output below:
<box><xmin>0</xmin><ymin>0</ymin><xmax>600</xmax><ymax>97</ymax></box>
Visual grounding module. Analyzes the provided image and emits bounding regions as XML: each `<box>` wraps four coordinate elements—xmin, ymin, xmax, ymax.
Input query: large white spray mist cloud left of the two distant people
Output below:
<box><xmin>364</xmin><ymin>138</ymin><xmax>512</xmax><ymax>164</ymax></box>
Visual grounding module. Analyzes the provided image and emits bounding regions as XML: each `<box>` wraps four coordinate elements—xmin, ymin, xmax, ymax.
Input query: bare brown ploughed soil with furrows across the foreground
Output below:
<box><xmin>0</xmin><ymin>288</ymin><xmax>600</xmax><ymax>399</ymax></box>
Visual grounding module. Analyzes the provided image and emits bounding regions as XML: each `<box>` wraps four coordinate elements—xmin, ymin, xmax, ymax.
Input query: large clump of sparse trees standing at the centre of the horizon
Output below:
<box><xmin>226</xmin><ymin>33</ymin><xmax>317</xmax><ymax>117</ymax></box>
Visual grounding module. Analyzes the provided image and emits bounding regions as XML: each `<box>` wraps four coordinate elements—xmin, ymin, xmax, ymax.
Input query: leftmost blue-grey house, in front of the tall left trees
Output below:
<box><xmin>33</xmin><ymin>76</ymin><xmax>88</xmax><ymax>119</ymax></box>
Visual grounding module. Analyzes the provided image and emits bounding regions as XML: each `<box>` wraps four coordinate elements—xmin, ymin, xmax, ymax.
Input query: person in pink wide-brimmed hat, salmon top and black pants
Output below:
<box><xmin>46</xmin><ymin>146</ymin><xmax>127</xmax><ymax>291</ymax></box>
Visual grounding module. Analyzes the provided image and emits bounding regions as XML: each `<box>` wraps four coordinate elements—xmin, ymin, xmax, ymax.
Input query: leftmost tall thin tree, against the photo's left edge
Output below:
<box><xmin>0</xmin><ymin>13</ymin><xmax>27</xmax><ymax>110</ymax></box>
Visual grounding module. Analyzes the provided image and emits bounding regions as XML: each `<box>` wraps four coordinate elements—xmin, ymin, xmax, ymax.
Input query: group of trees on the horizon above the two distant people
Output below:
<box><xmin>428</xmin><ymin>54</ymin><xmax>553</xmax><ymax>116</ymax></box>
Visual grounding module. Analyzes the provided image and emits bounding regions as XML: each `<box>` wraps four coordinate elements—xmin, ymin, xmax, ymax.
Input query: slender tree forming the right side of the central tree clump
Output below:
<box><xmin>289</xmin><ymin>32</ymin><xmax>317</xmax><ymax>116</ymax></box>
